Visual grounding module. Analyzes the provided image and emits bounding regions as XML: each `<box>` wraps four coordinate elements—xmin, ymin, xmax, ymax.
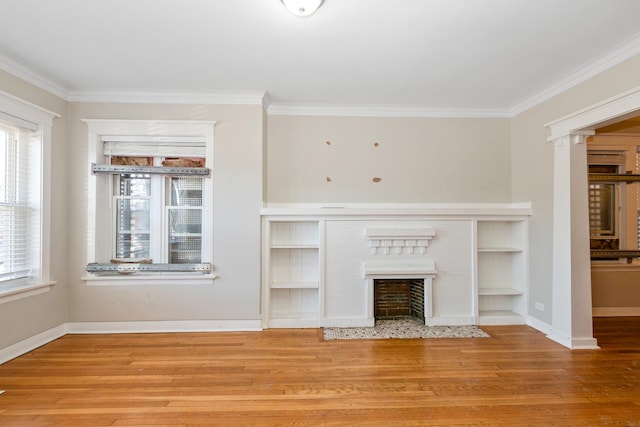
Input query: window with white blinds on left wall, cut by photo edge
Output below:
<box><xmin>0</xmin><ymin>92</ymin><xmax>56</xmax><ymax>302</ymax></box>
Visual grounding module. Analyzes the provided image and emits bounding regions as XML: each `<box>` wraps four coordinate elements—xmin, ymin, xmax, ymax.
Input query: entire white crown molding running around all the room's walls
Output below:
<box><xmin>0</xmin><ymin>30</ymin><xmax>640</xmax><ymax>118</ymax></box>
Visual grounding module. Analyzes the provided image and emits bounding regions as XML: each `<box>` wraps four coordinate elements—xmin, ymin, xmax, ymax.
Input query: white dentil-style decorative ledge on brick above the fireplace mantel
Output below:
<box><xmin>365</xmin><ymin>227</ymin><xmax>436</xmax><ymax>255</ymax></box>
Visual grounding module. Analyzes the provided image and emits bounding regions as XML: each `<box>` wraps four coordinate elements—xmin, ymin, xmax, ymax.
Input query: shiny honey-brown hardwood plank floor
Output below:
<box><xmin>0</xmin><ymin>318</ymin><xmax>640</xmax><ymax>427</ymax></box>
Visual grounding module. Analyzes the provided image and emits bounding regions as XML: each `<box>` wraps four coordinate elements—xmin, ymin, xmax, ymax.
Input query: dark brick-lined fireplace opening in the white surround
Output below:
<box><xmin>373</xmin><ymin>279</ymin><xmax>425</xmax><ymax>323</ymax></box>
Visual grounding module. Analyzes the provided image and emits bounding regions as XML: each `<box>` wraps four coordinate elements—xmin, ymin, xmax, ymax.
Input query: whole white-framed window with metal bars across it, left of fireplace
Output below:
<box><xmin>86</xmin><ymin>120</ymin><xmax>213</xmax><ymax>283</ymax></box>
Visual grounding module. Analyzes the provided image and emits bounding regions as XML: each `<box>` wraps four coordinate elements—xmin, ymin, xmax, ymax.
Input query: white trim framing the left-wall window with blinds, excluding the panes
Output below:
<box><xmin>0</xmin><ymin>91</ymin><xmax>60</xmax><ymax>304</ymax></box>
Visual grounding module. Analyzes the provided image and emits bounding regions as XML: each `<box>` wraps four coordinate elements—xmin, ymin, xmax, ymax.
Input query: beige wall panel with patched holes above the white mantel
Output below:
<box><xmin>267</xmin><ymin>116</ymin><xmax>511</xmax><ymax>203</ymax></box>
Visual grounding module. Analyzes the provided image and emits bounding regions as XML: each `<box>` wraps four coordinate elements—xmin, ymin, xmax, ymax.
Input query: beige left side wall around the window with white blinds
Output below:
<box><xmin>0</xmin><ymin>70</ymin><xmax>69</xmax><ymax>349</ymax></box>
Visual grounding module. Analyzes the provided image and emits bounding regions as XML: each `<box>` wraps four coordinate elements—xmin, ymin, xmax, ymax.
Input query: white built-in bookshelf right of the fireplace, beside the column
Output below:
<box><xmin>477</xmin><ymin>219</ymin><xmax>527</xmax><ymax>325</ymax></box>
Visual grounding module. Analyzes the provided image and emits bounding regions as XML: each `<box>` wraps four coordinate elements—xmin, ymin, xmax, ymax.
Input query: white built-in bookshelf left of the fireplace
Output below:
<box><xmin>263</xmin><ymin>219</ymin><xmax>322</xmax><ymax>328</ymax></box>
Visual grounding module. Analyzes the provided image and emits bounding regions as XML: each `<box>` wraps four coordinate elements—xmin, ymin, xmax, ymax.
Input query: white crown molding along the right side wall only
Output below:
<box><xmin>509</xmin><ymin>33</ymin><xmax>640</xmax><ymax>117</ymax></box>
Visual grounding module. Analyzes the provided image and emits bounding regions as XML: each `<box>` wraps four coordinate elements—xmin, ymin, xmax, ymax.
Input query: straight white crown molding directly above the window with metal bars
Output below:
<box><xmin>67</xmin><ymin>90</ymin><xmax>269</xmax><ymax>108</ymax></box>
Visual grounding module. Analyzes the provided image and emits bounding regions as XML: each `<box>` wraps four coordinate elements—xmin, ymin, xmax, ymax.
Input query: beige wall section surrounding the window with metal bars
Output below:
<box><xmin>68</xmin><ymin>103</ymin><xmax>263</xmax><ymax>322</ymax></box>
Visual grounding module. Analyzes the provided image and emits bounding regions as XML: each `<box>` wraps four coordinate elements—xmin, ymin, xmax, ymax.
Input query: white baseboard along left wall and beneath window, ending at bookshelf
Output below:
<box><xmin>0</xmin><ymin>319</ymin><xmax>262</xmax><ymax>365</ymax></box>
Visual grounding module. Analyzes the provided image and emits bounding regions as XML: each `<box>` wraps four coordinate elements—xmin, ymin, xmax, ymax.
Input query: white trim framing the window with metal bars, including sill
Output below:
<box><xmin>82</xmin><ymin>119</ymin><xmax>216</xmax><ymax>285</ymax></box>
